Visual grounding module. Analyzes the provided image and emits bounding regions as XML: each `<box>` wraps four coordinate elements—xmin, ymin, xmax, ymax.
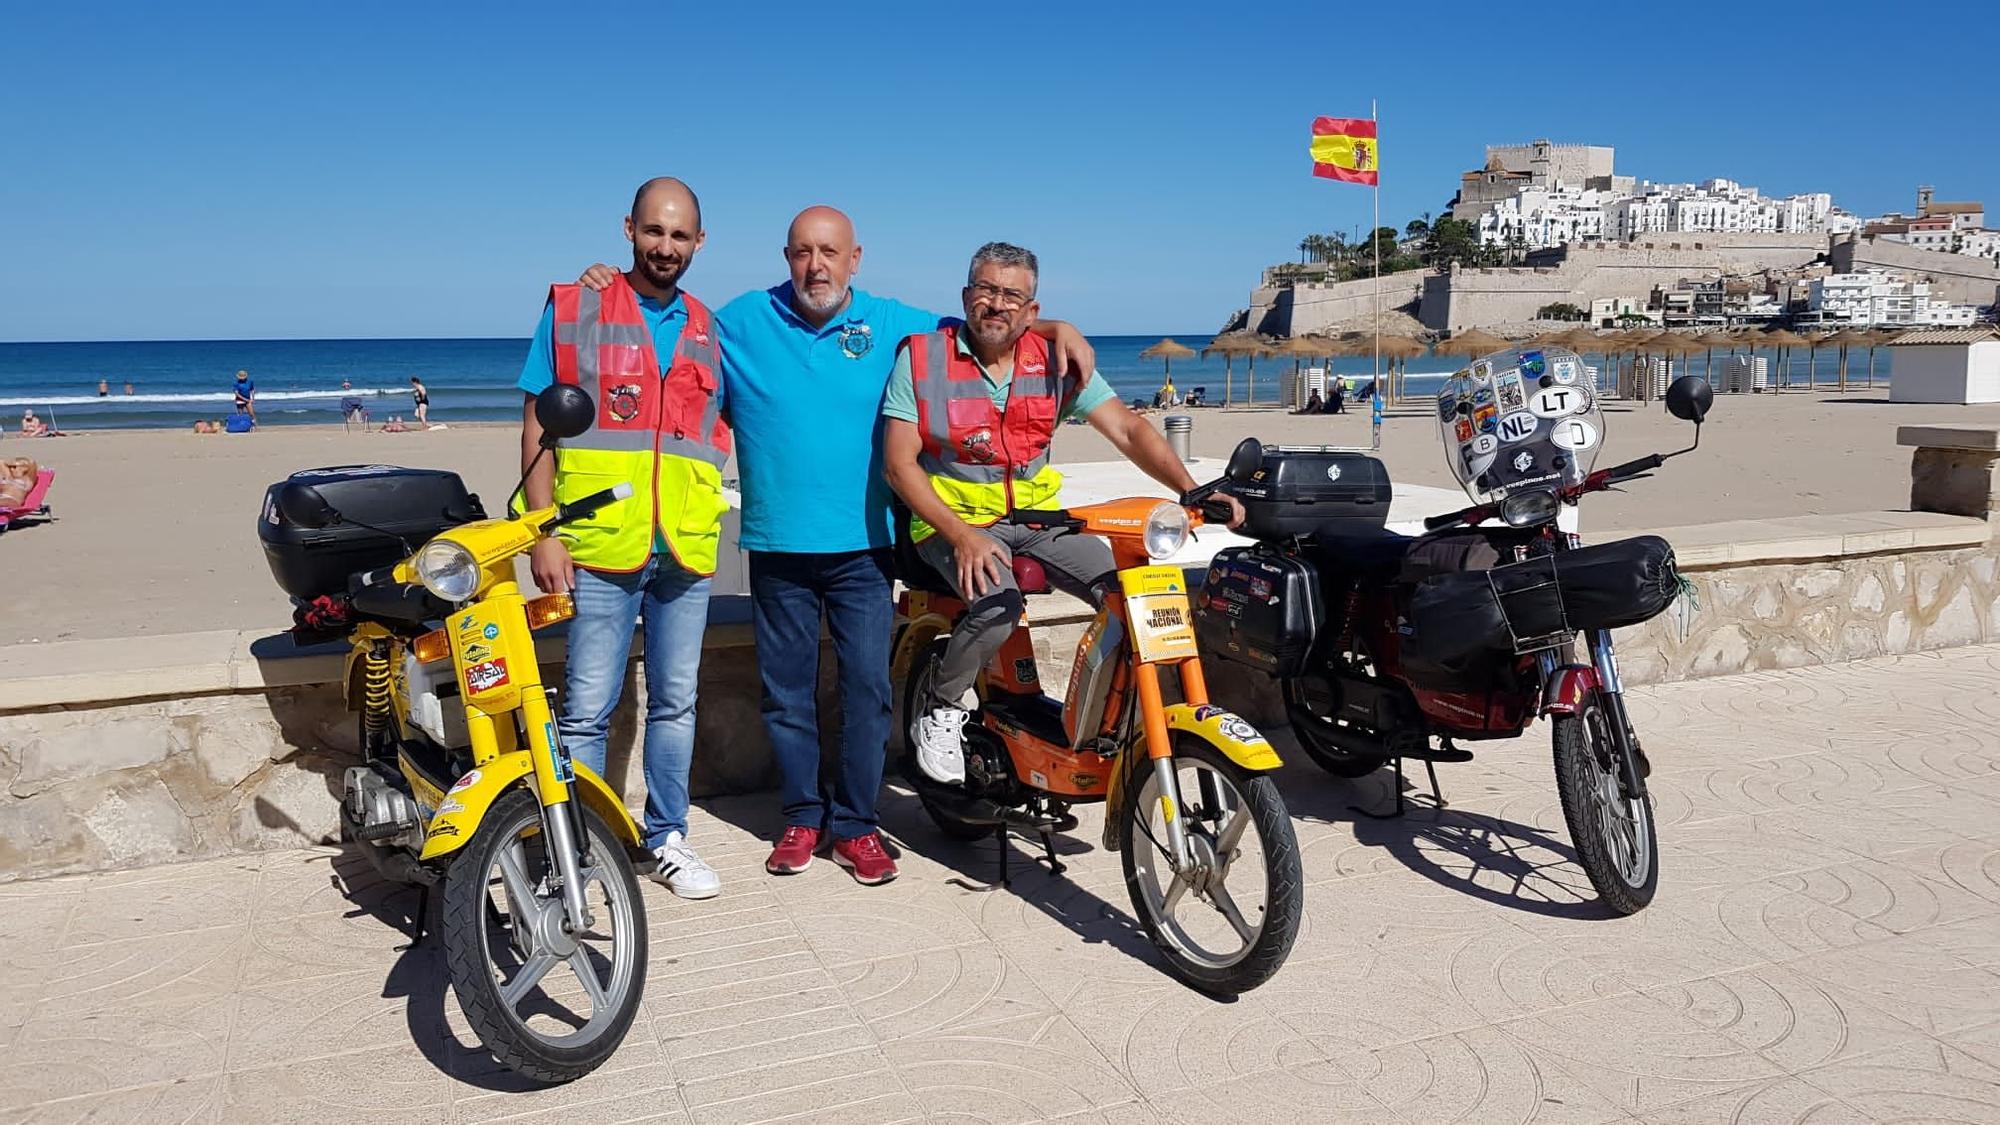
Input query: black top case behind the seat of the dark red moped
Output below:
<box><xmin>1230</xmin><ymin>446</ymin><xmax>1390</xmax><ymax>540</ymax></box>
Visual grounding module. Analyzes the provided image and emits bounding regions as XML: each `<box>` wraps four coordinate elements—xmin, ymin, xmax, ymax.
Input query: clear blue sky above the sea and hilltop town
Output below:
<box><xmin>0</xmin><ymin>0</ymin><xmax>2000</xmax><ymax>340</ymax></box>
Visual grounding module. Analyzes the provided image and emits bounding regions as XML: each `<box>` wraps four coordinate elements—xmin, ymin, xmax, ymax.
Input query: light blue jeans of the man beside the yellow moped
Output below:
<box><xmin>556</xmin><ymin>554</ymin><xmax>708</xmax><ymax>849</ymax></box>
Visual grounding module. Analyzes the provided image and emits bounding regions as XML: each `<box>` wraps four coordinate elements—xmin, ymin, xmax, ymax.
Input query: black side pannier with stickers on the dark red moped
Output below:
<box><xmin>1194</xmin><ymin>544</ymin><xmax>1326</xmax><ymax>677</ymax></box>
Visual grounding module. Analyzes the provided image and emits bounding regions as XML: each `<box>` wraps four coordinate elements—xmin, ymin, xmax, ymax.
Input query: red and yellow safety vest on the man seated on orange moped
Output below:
<box><xmin>904</xmin><ymin>328</ymin><xmax>1078</xmax><ymax>540</ymax></box>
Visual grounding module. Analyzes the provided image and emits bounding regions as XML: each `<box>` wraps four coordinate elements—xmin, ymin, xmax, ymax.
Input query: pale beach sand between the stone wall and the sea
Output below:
<box><xmin>0</xmin><ymin>392</ymin><xmax>2000</xmax><ymax>645</ymax></box>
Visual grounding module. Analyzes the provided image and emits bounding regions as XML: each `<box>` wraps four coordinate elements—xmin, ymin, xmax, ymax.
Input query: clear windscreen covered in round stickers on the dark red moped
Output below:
<box><xmin>1438</xmin><ymin>348</ymin><xmax>1604</xmax><ymax>504</ymax></box>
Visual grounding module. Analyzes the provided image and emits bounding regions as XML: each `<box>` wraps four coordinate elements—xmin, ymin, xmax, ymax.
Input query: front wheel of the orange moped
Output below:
<box><xmin>1116</xmin><ymin>735</ymin><xmax>1306</xmax><ymax>997</ymax></box>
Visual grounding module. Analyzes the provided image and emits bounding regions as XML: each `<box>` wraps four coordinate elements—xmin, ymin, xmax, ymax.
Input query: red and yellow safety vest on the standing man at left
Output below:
<box><xmin>548</xmin><ymin>276</ymin><xmax>732</xmax><ymax>575</ymax></box>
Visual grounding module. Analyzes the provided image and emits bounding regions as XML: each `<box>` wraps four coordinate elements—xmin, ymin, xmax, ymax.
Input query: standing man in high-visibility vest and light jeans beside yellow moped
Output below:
<box><xmin>520</xmin><ymin>178</ymin><xmax>730</xmax><ymax>899</ymax></box>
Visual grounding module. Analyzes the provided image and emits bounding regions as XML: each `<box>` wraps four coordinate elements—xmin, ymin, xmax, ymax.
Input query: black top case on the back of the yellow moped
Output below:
<box><xmin>256</xmin><ymin>464</ymin><xmax>486</xmax><ymax>601</ymax></box>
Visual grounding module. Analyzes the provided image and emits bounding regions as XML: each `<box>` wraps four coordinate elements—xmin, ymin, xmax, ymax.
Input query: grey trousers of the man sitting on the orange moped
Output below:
<box><xmin>916</xmin><ymin>522</ymin><xmax>1118</xmax><ymax>709</ymax></box>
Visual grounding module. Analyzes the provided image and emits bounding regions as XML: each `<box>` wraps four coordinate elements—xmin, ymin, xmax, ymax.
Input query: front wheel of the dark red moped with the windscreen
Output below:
<box><xmin>1556</xmin><ymin>695</ymin><xmax>1660</xmax><ymax>915</ymax></box>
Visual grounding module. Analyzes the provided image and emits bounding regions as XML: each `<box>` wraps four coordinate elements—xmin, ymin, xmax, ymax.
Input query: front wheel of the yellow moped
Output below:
<box><xmin>442</xmin><ymin>789</ymin><xmax>646</xmax><ymax>1083</ymax></box>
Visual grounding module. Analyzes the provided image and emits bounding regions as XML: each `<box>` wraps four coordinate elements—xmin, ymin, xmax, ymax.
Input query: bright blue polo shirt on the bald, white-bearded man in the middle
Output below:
<box><xmin>716</xmin><ymin>282</ymin><xmax>946</xmax><ymax>554</ymax></box>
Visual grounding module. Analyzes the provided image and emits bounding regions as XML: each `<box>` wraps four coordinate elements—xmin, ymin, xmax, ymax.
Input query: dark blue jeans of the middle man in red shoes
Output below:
<box><xmin>750</xmin><ymin>550</ymin><xmax>896</xmax><ymax>841</ymax></box>
